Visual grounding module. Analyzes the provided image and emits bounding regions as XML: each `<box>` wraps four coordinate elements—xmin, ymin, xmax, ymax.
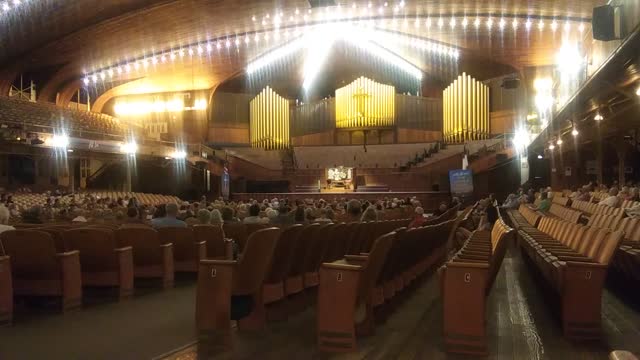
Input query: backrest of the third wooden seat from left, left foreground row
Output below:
<box><xmin>114</xmin><ymin>225</ymin><xmax>162</xmax><ymax>266</ymax></box>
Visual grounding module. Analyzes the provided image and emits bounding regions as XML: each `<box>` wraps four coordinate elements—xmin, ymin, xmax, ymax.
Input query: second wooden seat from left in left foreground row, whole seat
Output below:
<box><xmin>63</xmin><ymin>228</ymin><xmax>133</xmax><ymax>298</ymax></box>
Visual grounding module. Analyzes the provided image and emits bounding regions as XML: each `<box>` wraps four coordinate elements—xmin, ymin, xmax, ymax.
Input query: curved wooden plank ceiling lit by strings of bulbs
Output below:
<box><xmin>0</xmin><ymin>0</ymin><xmax>604</xmax><ymax>100</ymax></box>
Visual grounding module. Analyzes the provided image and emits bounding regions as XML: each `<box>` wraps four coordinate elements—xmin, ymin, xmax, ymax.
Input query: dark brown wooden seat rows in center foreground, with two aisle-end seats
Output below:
<box><xmin>196</xmin><ymin>208</ymin><xmax>457</xmax><ymax>351</ymax></box>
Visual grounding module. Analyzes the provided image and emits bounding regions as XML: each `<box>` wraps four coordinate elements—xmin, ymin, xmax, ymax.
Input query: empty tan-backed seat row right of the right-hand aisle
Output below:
<box><xmin>518</xmin><ymin>217</ymin><xmax>623</xmax><ymax>339</ymax></box>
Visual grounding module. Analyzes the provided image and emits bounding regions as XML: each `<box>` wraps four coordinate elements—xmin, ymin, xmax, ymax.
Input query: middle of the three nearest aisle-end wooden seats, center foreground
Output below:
<box><xmin>317</xmin><ymin>233</ymin><xmax>396</xmax><ymax>352</ymax></box>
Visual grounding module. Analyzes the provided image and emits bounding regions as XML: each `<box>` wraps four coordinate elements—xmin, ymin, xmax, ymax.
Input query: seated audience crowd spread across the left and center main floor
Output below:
<box><xmin>0</xmin><ymin>191</ymin><xmax>460</xmax><ymax>231</ymax></box>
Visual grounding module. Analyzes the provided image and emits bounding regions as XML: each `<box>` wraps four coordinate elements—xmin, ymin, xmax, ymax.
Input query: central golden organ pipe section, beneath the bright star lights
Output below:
<box><xmin>336</xmin><ymin>76</ymin><xmax>396</xmax><ymax>128</ymax></box>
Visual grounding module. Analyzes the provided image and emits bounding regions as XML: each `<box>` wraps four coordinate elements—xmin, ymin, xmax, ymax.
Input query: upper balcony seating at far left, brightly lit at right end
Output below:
<box><xmin>0</xmin><ymin>96</ymin><xmax>126</xmax><ymax>136</ymax></box>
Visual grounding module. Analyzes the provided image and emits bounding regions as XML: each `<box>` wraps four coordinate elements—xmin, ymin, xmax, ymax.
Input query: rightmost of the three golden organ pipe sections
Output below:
<box><xmin>442</xmin><ymin>73</ymin><xmax>490</xmax><ymax>143</ymax></box>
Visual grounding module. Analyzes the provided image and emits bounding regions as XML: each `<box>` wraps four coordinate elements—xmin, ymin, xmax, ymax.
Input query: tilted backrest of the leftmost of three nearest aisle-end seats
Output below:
<box><xmin>233</xmin><ymin>227</ymin><xmax>281</xmax><ymax>295</ymax></box>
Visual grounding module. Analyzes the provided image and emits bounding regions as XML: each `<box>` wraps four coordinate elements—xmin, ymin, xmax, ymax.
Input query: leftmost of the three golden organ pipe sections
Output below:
<box><xmin>249</xmin><ymin>86</ymin><xmax>291</xmax><ymax>150</ymax></box>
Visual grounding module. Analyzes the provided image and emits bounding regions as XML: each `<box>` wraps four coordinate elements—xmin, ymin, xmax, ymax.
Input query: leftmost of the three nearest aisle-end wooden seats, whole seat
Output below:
<box><xmin>196</xmin><ymin>228</ymin><xmax>280</xmax><ymax>347</ymax></box>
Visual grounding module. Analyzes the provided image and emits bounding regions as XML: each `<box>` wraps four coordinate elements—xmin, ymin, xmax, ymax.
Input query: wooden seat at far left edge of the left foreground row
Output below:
<box><xmin>0</xmin><ymin>230</ymin><xmax>82</xmax><ymax>310</ymax></box>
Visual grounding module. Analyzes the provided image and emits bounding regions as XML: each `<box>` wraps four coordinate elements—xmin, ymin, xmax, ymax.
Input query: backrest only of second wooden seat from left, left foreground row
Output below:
<box><xmin>62</xmin><ymin>228</ymin><xmax>117</xmax><ymax>272</ymax></box>
